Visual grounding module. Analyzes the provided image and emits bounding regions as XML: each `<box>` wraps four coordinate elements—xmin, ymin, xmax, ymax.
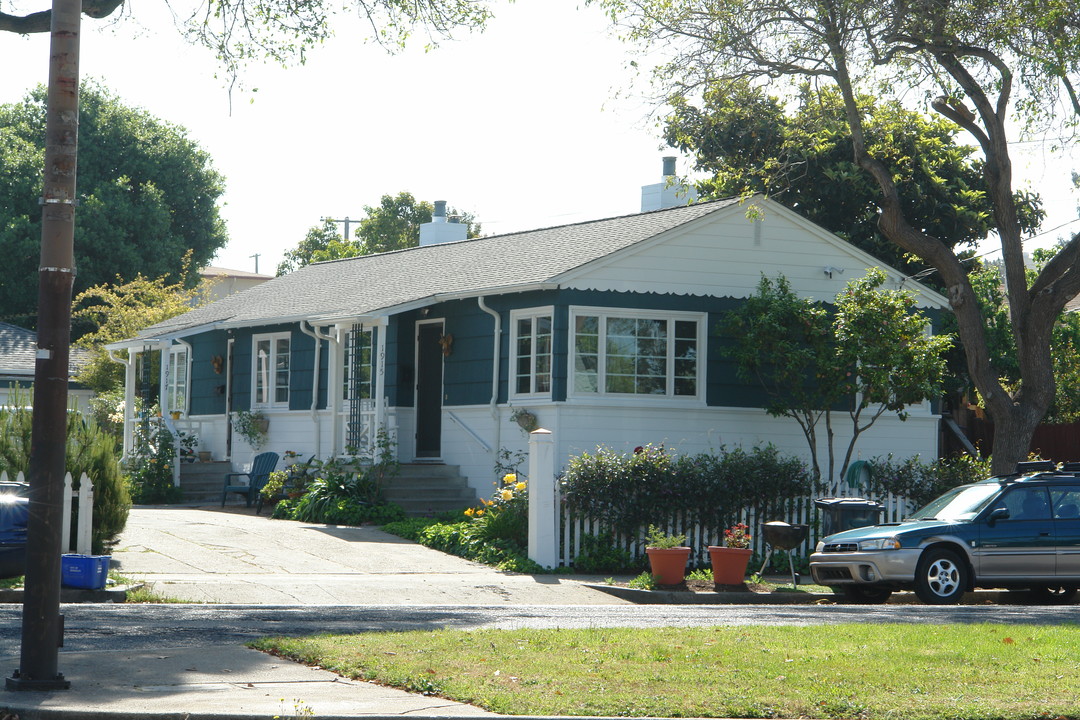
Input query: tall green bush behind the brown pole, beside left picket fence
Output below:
<box><xmin>0</xmin><ymin>396</ymin><xmax>132</xmax><ymax>554</ymax></box>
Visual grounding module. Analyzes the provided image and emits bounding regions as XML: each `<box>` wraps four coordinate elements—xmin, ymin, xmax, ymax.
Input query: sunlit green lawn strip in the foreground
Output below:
<box><xmin>253</xmin><ymin>625</ymin><xmax>1080</xmax><ymax>720</ymax></box>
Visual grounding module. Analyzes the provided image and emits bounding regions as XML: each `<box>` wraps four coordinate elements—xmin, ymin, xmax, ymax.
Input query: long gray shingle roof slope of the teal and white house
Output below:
<box><xmin>138</xmin><ymin>200</ymin><xmax>737</xmax><ymax>339</ymax></box>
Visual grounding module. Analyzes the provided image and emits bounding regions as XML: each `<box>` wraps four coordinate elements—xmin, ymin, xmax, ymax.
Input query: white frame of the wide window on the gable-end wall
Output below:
<box><xmin>567</xmin><ymin>305</ymin><xmax>708</xmax><ymax>405</ymax></box>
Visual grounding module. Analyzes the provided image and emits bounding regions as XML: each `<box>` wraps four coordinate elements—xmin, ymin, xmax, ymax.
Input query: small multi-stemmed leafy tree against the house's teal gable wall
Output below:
<box><xmin>725</xmin><ymin>268</ymin><xmax>953</xmax><ymax>479</ymax></box>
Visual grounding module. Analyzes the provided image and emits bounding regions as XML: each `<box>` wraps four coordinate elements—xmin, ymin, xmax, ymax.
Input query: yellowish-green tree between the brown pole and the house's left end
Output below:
<box><xmin>71</xmin><ymin>267</ymin><xmax>208</xmax><ymax>393</ymax></box>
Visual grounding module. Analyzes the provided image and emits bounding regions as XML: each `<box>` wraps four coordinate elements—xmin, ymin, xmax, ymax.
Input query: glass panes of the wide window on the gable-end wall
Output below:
<box><xmin>570</xmin><ymin>310</ymin><xmax>702</xmax><ymax>397</ymax></box>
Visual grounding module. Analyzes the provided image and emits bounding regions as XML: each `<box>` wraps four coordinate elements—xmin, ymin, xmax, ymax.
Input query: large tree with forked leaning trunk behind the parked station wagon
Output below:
<box><xmin>594</xmin><ymin>0</ymin><xmax>1080</xmax><ymax>473</ymax></box>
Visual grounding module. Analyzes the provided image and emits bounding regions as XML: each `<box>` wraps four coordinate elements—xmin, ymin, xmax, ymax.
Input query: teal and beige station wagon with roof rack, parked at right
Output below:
<box><xmin>810</xmin><ymin>463</ymin><xmax>1080</xmax><ymax>604</ymax></box>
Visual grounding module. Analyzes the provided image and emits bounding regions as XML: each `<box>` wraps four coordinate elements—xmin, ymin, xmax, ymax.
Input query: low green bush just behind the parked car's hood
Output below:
<box><xmin>866</xmin><ymin>454</ymin><xmax>990</xmax><ymax>507</ymax></box>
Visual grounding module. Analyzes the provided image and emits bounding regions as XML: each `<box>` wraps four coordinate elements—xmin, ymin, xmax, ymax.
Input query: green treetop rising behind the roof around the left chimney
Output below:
<box><xmin>278</xmin><ymin>192</ymin><xmax>480</xmax><ymax>275</ymax></box>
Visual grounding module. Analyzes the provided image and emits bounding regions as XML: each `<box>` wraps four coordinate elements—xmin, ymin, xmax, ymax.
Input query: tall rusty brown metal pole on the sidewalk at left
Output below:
<box><xmin>6</xmin><ymin>0</ymin><xmax>82</xmax><ymax>690</ymax></box>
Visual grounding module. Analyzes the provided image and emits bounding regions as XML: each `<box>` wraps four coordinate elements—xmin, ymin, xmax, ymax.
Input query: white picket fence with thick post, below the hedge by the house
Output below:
<box><xmin>528</xmin><ymin>430</ymin><xmax>916</xmax><ymax>568</ymax></box>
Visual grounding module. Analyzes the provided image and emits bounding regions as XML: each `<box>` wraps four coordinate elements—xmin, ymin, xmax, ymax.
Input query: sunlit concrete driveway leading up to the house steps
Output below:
<box><xmin>111</xmin><ymin>506</ymin><xmax>629</xmax><ymax>606</ymax></box>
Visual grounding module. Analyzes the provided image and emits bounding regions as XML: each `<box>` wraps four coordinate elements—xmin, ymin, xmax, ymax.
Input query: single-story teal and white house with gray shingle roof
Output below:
<box><xmin>112</xmin><ymin>188</ymin><xmax>946</xmax><ymax>497</ymax></box>
